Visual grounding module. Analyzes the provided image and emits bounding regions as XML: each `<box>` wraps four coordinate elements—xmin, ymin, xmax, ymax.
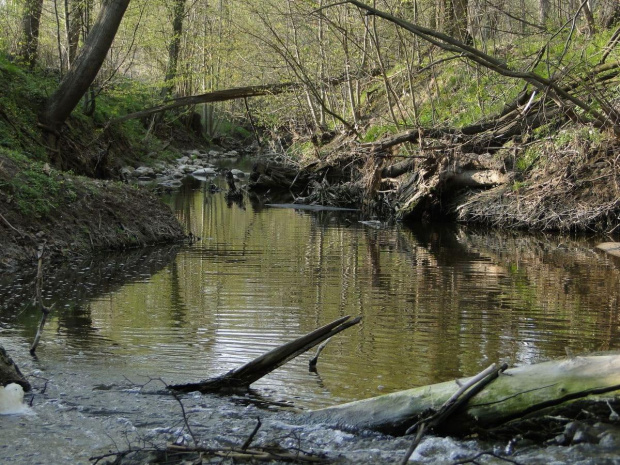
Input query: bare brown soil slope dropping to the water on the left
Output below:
<box><xmin>0</xmin><ymin>152</ymin><xmax>185</xmax><ymax>272</ymax></box>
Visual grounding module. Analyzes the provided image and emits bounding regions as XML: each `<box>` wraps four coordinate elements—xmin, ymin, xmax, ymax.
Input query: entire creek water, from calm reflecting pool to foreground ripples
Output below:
<box><xmin>0</xmin><ymin>161</ymin><xmax>620</xmax><ymax>463</ymax></box>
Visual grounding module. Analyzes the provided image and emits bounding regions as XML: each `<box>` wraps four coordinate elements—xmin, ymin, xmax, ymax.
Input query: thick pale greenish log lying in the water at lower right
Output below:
<box><xmin>308</xmin><ymin>354</ymin><xmax>620</xmax><ymax>435</ymax></box>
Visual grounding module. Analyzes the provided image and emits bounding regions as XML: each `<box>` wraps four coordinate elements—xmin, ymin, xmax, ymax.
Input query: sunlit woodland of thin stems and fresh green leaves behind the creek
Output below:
<box><xmin>0</xmin><ymin>0</ymin><xmax>620</xmax><ymax>140</ymax></box>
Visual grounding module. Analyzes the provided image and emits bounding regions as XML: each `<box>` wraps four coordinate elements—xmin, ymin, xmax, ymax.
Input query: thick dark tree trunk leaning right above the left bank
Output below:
<box><xmin>40</xmin><ymin>0</ymin><xmax>130</xmax><ymax>134</ymax></box>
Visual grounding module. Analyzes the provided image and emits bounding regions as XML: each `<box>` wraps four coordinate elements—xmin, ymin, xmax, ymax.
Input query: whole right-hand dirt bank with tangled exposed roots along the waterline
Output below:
<box><xmin>250</xmin><ymin>127</ymin><xmax>620</xmax><ymax>233</ymax></box>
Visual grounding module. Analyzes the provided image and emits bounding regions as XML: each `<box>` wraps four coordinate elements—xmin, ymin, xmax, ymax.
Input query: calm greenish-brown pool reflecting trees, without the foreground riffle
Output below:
<box><xmin>0</xmin><ymin>173</ymin><xmax>620</xmax><ymax>407</ymax></box>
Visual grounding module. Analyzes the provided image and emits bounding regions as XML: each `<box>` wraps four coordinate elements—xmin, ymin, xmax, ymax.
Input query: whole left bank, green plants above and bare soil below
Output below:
<box><xmin>0</xmin><ymin>55</ymin><xmax>191</xmax><ymax>271</ymax></box>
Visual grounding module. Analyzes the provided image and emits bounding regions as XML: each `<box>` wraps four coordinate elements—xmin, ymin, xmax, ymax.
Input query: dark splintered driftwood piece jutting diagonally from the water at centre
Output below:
<box><xmin>168</xmin><ymin>316</ymin><xmax>362</xmax><ymax>393</ymax></box>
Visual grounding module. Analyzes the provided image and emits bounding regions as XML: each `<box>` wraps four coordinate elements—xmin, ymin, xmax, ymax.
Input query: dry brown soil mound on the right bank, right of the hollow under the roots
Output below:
<box><xmin>453</xmin><ymin>140</ymin><xmax>620</xmax><ymax>233</ymax></box>
